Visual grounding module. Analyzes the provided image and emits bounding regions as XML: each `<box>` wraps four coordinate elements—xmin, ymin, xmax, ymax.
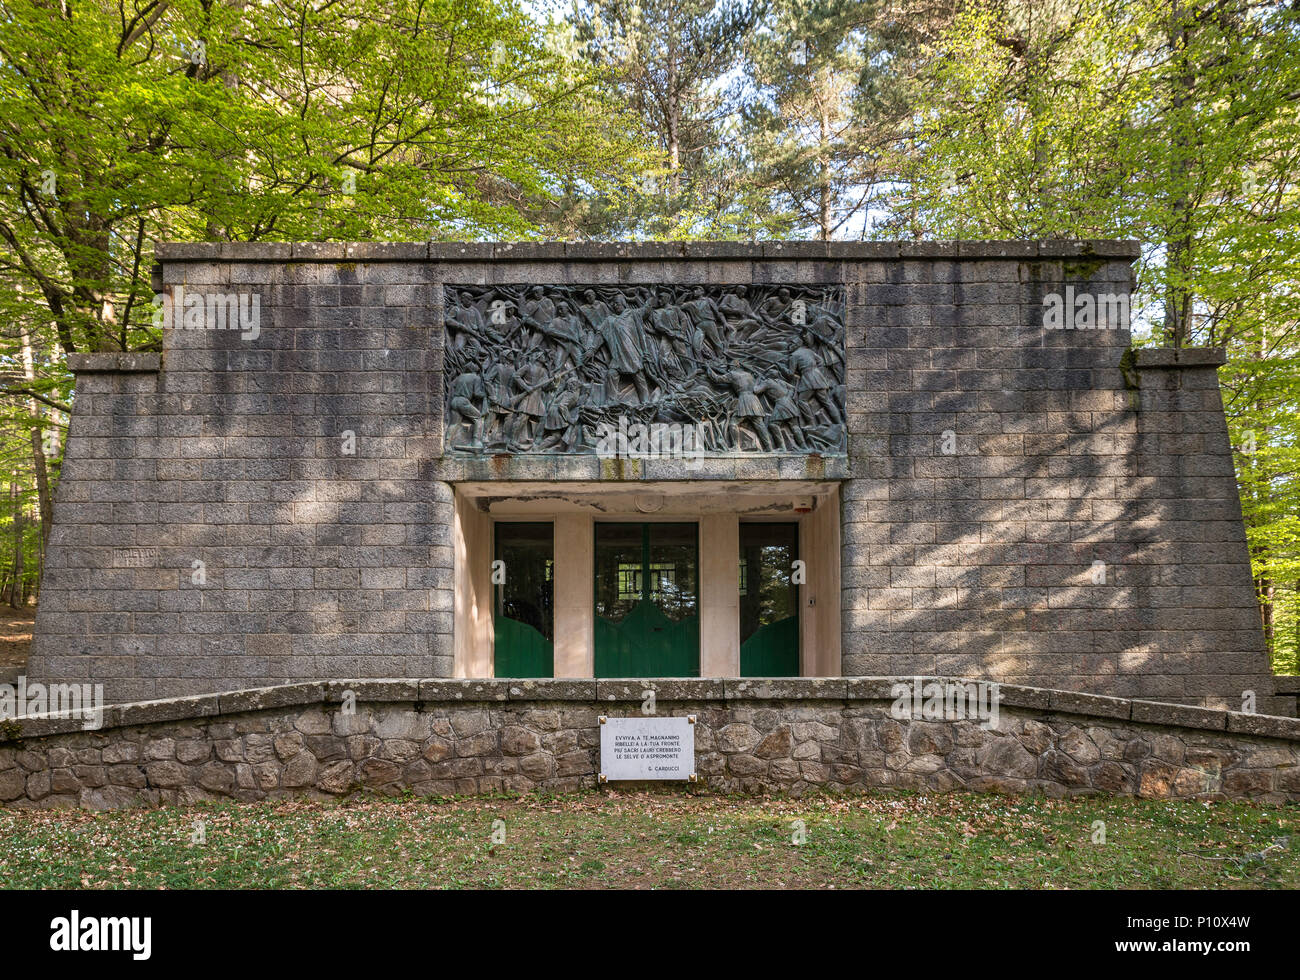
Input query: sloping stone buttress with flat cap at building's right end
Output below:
<box><xmin>1133</xmin><ymin>347</ymin><xmax>1295</xmax><ymax>715</ymax></box>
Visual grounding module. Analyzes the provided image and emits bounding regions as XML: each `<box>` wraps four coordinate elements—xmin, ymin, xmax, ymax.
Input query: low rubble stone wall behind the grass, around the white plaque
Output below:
<box><xmin>0</xmin><ymin>677</ymin><xmax>1300</xmax><ymax>808</ymax></box>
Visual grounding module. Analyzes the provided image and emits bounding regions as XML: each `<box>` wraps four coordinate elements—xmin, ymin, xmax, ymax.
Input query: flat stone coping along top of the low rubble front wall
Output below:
<box><xmin>0</xmin><ymin>676</ymin><xmax>1300</xmax><ymax>742</ymax></box>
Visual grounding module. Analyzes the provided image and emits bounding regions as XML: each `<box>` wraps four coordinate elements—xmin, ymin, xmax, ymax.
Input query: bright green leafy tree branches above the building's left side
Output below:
<box><xmin>0</xmin><ymin>0</ymin><xmax>627</xmax><ymax>351</ymax></box>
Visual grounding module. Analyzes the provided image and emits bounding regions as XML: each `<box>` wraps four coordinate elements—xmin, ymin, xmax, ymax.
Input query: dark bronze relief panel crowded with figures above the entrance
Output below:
<box><xmin>446</xmin><ymin>285</ymin><xmax>846</xmax><ymax>454</ymax></box>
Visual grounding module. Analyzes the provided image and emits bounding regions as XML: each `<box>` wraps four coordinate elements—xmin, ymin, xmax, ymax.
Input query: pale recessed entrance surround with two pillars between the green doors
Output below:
<box><xmin>457</xmin><ymin>480</ymin><xmax>842</xmax><ymax>678</ymax></box>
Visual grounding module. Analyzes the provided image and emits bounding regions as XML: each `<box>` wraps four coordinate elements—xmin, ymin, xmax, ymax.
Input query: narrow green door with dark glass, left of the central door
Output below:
<box><xmin>493</xmin><ymin>522</ymin><xmax>555</xmax><ymax>677</ymax></box>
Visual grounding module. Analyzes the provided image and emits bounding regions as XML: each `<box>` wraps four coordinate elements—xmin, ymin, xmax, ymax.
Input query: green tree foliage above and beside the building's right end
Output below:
<box><xmin>889</xmin><ymin>0</ymin><xmax>1300</xmax><ymax>669</ymax></box>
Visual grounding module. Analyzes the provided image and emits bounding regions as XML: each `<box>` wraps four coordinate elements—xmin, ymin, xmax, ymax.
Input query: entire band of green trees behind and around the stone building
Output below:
<box><xmin>0</xmin><ymin>0</ymin><xmax>1300</xmax><ymax>669</ymax></box>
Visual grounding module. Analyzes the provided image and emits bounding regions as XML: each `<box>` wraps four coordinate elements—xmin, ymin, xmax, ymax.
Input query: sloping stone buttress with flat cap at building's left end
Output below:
<box><xmin>25</xmin><ymin>354</ymin><xmax>162</xmax><ymax>701</ymax></box>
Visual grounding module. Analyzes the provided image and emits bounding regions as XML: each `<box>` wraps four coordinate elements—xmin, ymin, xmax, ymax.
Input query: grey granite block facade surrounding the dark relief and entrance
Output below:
<box><xmin>29</xmin><ymin>242</ymin><xmax>1294</xmax><ymax>714</ymax></box>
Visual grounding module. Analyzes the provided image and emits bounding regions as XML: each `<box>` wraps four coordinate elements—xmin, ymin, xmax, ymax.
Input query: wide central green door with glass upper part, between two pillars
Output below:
<box><xmin>595</xmin><ymin>524</ymin><xmax>699</xmax><ymax>677</ymax></box>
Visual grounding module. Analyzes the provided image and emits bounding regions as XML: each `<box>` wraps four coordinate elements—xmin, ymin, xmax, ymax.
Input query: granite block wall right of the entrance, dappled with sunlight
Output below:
<box><xmin>842</xmin><ymin>250</ymin><xmax>1268</xmax><ymax>711</ymax></box>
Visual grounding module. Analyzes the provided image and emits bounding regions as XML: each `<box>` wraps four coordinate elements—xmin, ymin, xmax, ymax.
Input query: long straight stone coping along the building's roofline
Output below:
<box><xmin>153</xmin><ymin>239</ymin><xmax>1141</xmax><ymax>263</ymax></box>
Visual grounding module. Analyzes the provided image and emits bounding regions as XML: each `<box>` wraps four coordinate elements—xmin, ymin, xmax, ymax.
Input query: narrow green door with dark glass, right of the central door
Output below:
<box><xmin>740</xmin><ymin>521</ymin><xmax>800</xmax><ymax>677</ymax></box>
